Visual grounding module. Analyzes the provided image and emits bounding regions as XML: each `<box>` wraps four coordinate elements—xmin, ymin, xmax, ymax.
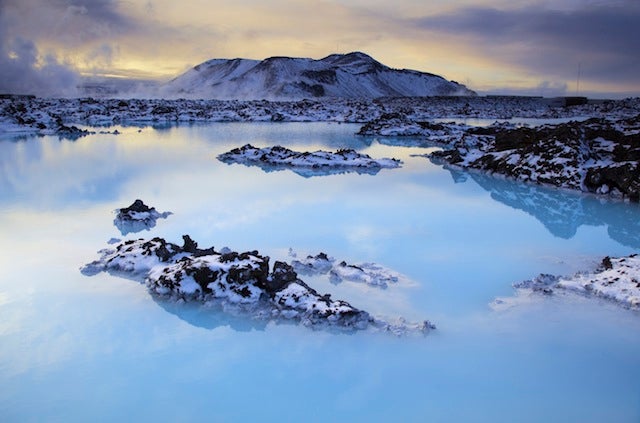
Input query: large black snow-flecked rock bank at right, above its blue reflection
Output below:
<box><xmin>430</xmin><ymin>115</ymin><xmax>640</xmax><ymax>201</ymax></box>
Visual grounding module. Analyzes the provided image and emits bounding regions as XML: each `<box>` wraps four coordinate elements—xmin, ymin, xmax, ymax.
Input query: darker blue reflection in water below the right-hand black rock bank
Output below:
<box><xmin>450</xmin><ymin>169</ymin><xmax>640</xmax><ymax>248</ymax></box>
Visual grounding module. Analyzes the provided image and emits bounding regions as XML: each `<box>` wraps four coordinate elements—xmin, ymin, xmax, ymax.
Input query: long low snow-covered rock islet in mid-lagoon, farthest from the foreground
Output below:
<box><xmin>218</xmin><ymin>144</ymin><xmax>402</xmax><ymax>177</ymax></box>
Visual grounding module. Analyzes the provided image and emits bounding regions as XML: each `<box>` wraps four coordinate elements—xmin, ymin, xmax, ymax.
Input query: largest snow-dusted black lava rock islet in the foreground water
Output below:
<box><xmin>81</xmin><ymin>235</ymin><xmax>433</xmax><ymax>333</ymax></box>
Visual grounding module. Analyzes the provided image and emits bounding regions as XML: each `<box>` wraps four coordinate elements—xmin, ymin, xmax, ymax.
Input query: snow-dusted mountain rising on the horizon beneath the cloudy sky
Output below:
<box><xmin>161</xmin><ymin>52</ymin><xmax>476</xmax><ymax>100</ymax></box>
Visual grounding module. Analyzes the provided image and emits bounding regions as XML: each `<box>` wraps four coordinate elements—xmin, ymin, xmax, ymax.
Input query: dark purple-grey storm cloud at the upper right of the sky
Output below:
<box><xmin>416</xmin><ymin>0</ymin><xmax>640</xmax><ymax>90</ymax></box>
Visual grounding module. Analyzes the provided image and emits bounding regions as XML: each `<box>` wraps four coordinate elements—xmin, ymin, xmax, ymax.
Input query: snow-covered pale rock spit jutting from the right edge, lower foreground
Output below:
<box><xmin>514</xmin><ymin>254</ymin><xmax>640</xmax><ymax>310</ymax></box>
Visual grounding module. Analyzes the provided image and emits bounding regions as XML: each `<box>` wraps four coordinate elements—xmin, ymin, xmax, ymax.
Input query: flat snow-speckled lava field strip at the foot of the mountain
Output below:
<box><xmin>5</xmin><ymin>96</ymin><xmax>640</xmax><ymax>137</ymax></box>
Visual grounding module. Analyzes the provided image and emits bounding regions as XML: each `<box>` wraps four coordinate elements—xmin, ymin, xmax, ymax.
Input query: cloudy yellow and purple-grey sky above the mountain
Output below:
<box><xmin>0</xmin><ymin>0</ymin><xmax>640</xmax><ymax>98</ymax></box>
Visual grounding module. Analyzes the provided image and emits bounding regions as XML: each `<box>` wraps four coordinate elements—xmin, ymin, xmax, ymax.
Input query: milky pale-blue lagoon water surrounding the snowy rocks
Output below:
<box><xmin>0</xmin><ymin>123</ymin><xmax>640</xmax><ymax>422</ymax></box>
